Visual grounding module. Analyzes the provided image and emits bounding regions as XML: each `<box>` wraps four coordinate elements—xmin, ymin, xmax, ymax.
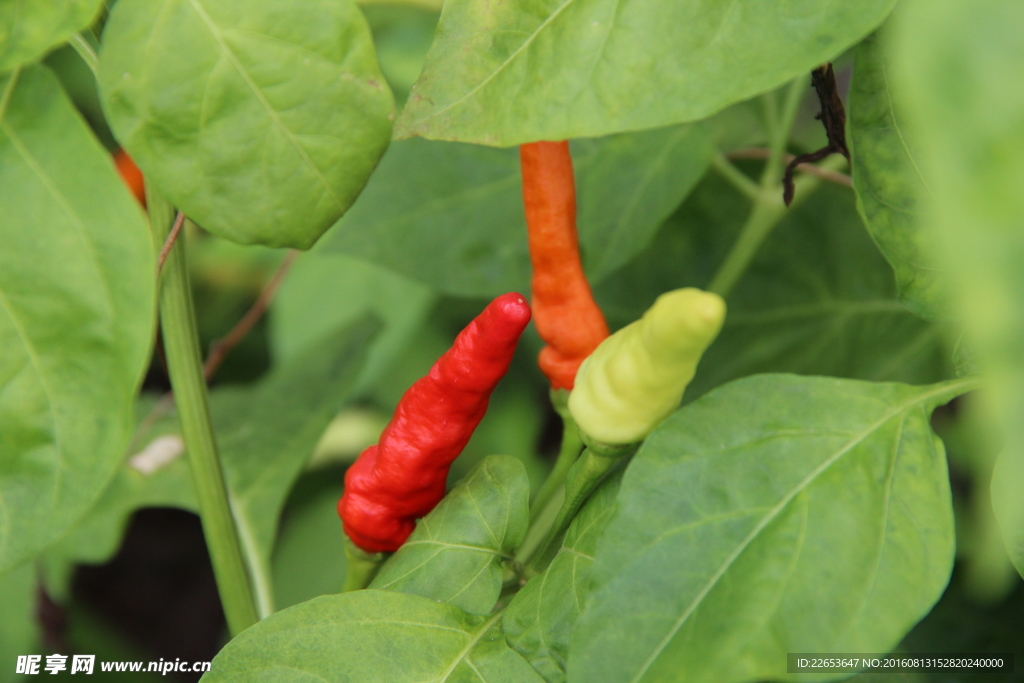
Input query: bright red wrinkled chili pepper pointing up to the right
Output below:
<box><xmin>338</xmin><ymin>293</ymin><xmax>530</xmax><ymax>553</ymax></box>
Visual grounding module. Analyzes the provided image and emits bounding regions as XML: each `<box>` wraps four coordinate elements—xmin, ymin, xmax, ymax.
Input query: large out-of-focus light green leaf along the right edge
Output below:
<box><xmin>889</xmin><ymin>0</ymin><xmax>1024</xmax><ymax>581</ymax></box>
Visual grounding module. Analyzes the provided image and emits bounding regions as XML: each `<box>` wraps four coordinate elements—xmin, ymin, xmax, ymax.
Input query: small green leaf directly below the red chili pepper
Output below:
<box><xmin>370</xmin><ymin>456</ymin><xmax>529</xmax><ymax>614</ymax></box>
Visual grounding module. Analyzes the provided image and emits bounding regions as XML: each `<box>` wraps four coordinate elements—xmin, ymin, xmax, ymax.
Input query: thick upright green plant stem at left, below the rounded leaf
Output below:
<box><xmin>146</xmin><ymin>188</ymin><xmax>259</xmax><ymax>635</ymax></box>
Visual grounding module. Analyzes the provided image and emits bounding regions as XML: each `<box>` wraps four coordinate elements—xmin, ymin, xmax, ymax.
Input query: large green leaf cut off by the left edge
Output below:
<box><xmin>0</xmin><ymin>67</ymin><xmax>156</xmax><ymax>571</ymax></box>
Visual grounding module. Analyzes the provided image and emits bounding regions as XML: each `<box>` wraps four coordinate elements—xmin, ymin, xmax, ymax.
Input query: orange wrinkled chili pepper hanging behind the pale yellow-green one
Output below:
<box><xmin>519</xmin><ymin>141</ymin><xmax>608</xmax><ymax>389</ymax></box>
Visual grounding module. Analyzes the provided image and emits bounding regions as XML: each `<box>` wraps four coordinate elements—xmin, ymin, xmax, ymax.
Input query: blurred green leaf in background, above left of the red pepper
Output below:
<box><xmin>270</xmin><ymin>253</ymin><xmax>434</xmax><ymax>391</ymax></box>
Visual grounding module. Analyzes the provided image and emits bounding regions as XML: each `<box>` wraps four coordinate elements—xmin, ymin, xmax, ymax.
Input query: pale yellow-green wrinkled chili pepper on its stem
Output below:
<box><xmin>568</xmin><ymin>288</ymin><xmax>725</xmax><ymax>445</ymax></box>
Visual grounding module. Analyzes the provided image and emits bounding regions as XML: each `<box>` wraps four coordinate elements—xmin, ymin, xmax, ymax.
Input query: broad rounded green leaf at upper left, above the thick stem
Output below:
<box><xmin>99</xmin><ymin>0</ymin><xmax>393</xmax><ymax>249</ymax></box>
